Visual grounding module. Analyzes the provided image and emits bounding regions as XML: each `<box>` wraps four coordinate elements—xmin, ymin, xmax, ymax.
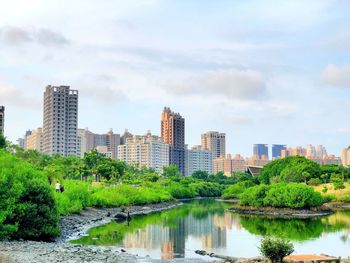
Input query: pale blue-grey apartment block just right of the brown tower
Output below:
<box><xmin>186</xmin><ymin>145</ymin><xmax>213</xmax><ymax>175</ymax></box>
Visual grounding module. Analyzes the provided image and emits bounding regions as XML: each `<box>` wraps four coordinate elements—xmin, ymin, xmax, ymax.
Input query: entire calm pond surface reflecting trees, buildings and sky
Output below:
<box><xmin>72</xmin><ymin>200</ymin><xmax>350</xmax><ymax>259</ymax></box>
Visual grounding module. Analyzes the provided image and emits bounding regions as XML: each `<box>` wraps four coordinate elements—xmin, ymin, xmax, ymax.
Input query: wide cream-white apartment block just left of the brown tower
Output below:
<box><xmin>118</xmin><ymin>132</ymin><xmax>170</xmax><ymax>173</ymax></box>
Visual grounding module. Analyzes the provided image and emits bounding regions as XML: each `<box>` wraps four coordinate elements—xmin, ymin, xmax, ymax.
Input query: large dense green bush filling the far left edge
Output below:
<box><xmin>0</xmin><ymin>151</ymin><xmax>59</xmax><ymax>240</ymax></box>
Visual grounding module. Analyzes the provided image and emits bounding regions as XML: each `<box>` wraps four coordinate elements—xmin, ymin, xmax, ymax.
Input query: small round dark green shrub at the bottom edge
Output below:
<box><xmin>259</xmin><ymin>237</ymin><xmax>294</xmax><ymax>263</ymax></box>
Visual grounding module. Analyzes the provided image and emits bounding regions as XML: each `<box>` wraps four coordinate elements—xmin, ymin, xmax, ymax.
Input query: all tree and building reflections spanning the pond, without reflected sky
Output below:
<box><xmin>71</xmin><ymin>200</ymin><xmax>350</xmax><ymax>259</ymax></box>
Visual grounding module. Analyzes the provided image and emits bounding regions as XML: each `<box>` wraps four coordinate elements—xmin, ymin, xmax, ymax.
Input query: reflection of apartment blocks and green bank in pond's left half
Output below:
<box><xmin>70</xmin><ymin>200</ymin><xmax>228</xmax><ymax>259</ymax></box>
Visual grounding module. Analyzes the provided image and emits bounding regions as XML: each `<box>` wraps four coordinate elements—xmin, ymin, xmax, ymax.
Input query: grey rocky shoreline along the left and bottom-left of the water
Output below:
<box><xmin>0</xmin><ymin>201</ymin><xmax>218</xmax><ymax>263</ymax></box>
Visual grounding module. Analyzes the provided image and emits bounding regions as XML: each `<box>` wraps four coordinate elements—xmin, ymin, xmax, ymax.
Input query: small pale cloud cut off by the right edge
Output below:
<box><xmin>322</xmin><ymin>64</ymin><xmax>350</xmax><ymax>88</ymax></box>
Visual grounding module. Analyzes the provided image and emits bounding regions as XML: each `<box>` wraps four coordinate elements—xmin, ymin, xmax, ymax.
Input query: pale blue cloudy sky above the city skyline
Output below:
<box><xmin>0</xmin><ymin>0</ymin><xmax>350</xmax><ymax>156</ymax></box>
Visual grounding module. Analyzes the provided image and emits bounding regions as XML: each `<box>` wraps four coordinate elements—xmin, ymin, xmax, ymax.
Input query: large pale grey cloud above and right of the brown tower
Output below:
<box><xmin>166</xmin><ymin>69</ymin><xmax>266</xmax><ymax>100</ymax></box>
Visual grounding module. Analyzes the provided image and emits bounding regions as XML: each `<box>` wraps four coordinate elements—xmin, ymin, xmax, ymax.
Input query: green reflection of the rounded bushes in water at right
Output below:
<box><xmin>240</xmin><ymin>212</ymin><xmax>350</xmax><ymax>241</ymax></box>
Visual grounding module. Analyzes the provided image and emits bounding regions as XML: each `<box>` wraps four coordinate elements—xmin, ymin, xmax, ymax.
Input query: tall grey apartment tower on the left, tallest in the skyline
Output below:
<box><xmin>42</xmin><ymin>85</ymin><xmax>79</xmax><ymax>156</ymax></box>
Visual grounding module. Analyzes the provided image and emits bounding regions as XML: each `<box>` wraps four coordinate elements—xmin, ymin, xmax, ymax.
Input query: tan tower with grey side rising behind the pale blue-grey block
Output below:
<box><xmin>201</xmin><ymin>131</ymin><xmax>226</xmax><ymax>159</ymax></box>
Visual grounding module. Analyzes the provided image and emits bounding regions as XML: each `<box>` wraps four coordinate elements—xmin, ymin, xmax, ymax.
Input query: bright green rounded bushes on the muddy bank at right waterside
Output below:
<box><xmin>241</xmin><ymin>183</ymin><xmax>323</xmax><ymax>208</ymax></box>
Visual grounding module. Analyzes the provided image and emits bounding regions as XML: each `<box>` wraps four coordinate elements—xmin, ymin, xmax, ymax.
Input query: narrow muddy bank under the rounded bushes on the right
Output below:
<box><xmin>228</xmin><ymin>205</ymin><xmax>334</xmax><ymax>219</ymax></box>
